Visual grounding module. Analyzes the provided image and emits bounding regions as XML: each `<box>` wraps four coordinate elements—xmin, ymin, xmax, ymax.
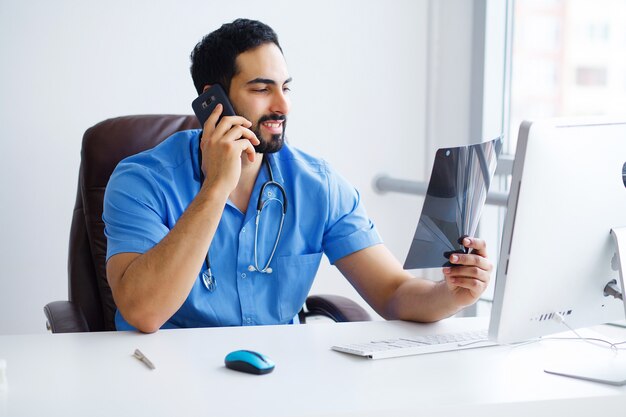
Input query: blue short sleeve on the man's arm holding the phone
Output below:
<box><xmin>102</xmin><ymin>163</ymin><xmax>169</xmax><ymax>260</ymax></box>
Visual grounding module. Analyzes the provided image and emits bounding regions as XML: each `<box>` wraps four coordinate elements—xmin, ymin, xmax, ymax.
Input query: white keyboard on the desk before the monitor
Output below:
<box><xmin>332</xmin><ymin>330</ymin><xmax>496</xmax><ymax>359</ymax></box>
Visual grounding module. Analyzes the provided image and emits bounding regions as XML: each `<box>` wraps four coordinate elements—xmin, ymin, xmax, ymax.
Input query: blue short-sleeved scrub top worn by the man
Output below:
<box><xmin>102</xmin><ymin>130</ymin><xmax>381</xmax><ymax>330</ymax></box>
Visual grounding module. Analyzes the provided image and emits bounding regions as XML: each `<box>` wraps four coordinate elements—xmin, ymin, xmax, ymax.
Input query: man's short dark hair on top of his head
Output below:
<box><xmin>191</xmin><ymin>19</ymin><xmax>283</xmax><ymax>94</ymax></box>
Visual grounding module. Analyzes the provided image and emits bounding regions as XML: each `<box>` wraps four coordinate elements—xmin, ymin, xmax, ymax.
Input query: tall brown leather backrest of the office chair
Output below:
<box><xmin>68</xmin><ymin>115</ymin><xmax>199</xmax><ymax>331</ymax></box>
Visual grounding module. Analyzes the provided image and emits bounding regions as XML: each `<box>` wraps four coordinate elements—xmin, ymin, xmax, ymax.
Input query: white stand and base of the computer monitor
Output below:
<box><xmin>544</xmin><ymin>227</ymin><xmax>626</xmax><ymax>386</ymax></box>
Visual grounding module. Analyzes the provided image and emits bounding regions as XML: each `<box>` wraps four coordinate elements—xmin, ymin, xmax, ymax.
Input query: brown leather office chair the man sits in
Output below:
<box><xmin>44</xmin><ymin>115</ymin><xmax>370</xmax><ymax>333</ymax></box>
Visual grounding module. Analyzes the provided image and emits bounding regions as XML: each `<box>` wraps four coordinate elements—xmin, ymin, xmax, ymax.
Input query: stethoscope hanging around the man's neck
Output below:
<box><xmin>198</xmin><ymin>152</ymin><xmax>287</xmax><ymax>292</ymax></box>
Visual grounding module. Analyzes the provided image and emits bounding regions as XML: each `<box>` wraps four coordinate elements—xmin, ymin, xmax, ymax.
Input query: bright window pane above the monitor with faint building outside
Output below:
<box><xmin>508</xmin><ymin>0</ymin><xmax>626</xmax><ymax>151</ymax></box>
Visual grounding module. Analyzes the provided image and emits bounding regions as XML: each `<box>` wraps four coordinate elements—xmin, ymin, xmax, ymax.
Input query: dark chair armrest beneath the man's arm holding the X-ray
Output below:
<box><xmin>301</xmin><ymin>295</ymin><xmax>372</xmax><ymax>323</ymax></box>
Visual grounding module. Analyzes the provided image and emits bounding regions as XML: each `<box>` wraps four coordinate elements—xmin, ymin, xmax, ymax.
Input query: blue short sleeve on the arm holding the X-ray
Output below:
<box><xmin>323</xmin><ymin>162</ymin><xmax>382</xmax><ymax>264</ymax></box>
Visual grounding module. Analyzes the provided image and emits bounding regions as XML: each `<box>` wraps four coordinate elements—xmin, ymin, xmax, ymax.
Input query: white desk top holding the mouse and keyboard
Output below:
<box><xmin>0</xmin><ymin>318</ymin><xmax>626</xmax><ymax>417</ymax></box>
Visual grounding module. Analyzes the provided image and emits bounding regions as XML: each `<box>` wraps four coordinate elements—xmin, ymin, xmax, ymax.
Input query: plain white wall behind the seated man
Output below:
<box><xmin>0</xmin><ymin>0</ymin><xmax>429</xmax><ymax>334</ymax></box>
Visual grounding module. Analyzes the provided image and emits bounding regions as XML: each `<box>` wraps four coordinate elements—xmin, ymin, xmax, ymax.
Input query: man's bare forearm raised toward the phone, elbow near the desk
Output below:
<box><xmin>107</xmin><ymin>187</ymin><xmax>228</xmax><ymax>332</ymax></box>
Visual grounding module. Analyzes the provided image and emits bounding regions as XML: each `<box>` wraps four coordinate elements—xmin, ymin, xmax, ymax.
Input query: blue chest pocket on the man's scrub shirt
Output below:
<box><xmin>276</xmin><ymin>252</ymin><xmax>322</xmax><ymax>323</ymax></box>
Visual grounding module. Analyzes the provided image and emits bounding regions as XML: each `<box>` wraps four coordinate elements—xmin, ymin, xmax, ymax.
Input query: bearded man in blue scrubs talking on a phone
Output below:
<box><xmin>103</xmin><ymin>19</ymin><xmax>492</xmax><ymax>332</ymax></box>
